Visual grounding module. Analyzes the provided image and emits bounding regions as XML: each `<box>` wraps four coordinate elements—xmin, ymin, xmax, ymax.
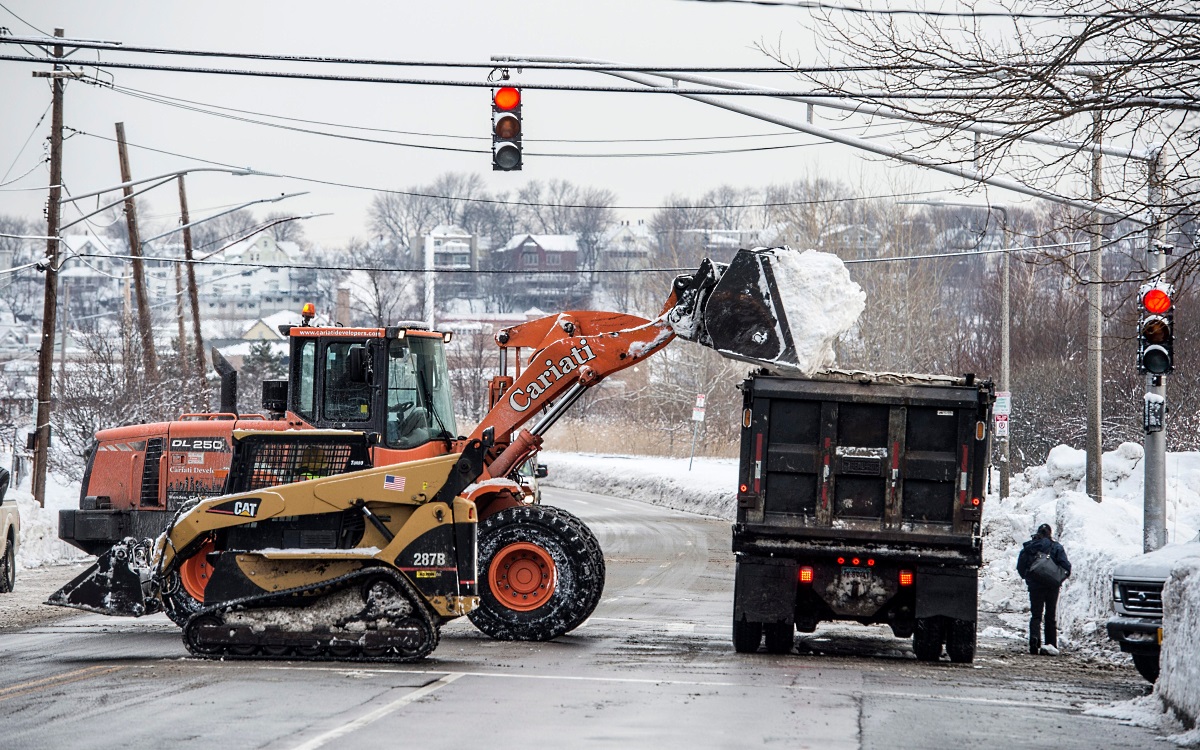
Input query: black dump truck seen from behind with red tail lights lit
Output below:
<box><xmin>733</xmin><ymin>370</ymin><xmax>995</xmax><ymax>662</ymax></box>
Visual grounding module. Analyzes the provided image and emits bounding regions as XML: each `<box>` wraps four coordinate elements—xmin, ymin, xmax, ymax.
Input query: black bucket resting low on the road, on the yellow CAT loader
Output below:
<box><xmin>46</xmin><ymin>538</ymin><xmax>162</xmax><ymax>617</ymax></box>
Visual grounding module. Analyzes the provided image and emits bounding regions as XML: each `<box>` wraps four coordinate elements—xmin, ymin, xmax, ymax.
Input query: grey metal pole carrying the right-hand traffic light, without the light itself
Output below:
<box><xmin>1141</xmin><ymin>151</ymin><xmax>1168</xmax><ymax>552</ymax></box>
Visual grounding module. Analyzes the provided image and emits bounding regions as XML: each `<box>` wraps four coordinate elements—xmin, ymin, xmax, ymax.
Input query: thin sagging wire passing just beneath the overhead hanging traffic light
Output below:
<box><xmin>66</xmin><ymin>127</ymin><xmax>964</xmax><ymax>211</ymax></box>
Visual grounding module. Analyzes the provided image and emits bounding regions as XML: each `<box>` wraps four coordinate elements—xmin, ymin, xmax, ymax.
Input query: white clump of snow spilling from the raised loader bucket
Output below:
<box><xmin>770</xmin><ymin>247</ymin><xmax>866</xmax><ymax>374</ymax></box>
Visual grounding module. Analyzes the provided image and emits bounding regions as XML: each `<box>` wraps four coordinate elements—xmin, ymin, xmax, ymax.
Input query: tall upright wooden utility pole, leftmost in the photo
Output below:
<box><xmin>32</xmin><ymin>29</ymin><xmax>64</xmax><ymax>508</ymax></box>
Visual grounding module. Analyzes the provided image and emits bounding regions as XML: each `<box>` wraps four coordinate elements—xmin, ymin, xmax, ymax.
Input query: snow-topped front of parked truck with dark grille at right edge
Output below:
<box><xmin>1108</xmin><ymin>535</ymin><xmax>1200</xmax><ymax>683</ymax></box>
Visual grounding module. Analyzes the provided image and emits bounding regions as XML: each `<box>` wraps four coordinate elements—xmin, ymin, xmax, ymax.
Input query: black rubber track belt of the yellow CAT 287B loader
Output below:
<box><xmin>184</xmin><ymin>568</ymin><xmax>440</xmax><ymax>664</ymax></box>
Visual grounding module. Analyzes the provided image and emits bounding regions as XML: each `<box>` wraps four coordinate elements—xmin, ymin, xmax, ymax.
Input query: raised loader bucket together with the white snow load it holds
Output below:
<box><xmin>668</xmin><ymin>247</ymin><xmax>865</xmax><ymax>372</ymax></box>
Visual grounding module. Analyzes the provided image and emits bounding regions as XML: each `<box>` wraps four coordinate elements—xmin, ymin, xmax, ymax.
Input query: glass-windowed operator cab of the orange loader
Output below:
<box><xmin>288</xmin><ymin>326</ymin><xmax>457</xmax><ymax>450</ymax></box>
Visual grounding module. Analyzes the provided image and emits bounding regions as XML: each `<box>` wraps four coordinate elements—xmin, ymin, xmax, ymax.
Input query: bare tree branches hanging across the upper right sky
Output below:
<box><xmin>768</xmin><ymin>0</ymin><xmax>1200</xmax><ymax>272</ymax></box>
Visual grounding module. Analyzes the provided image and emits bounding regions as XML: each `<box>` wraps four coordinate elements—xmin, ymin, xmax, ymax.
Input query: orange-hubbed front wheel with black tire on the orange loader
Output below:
<box><xmin>468</xmin><ymin>505</ymin><xmax>605</xmax><ymax>641</ymax></box>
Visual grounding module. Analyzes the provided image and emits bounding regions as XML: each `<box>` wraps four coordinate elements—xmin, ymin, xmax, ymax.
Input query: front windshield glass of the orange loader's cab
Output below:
<box><xmin>386</xmin><ymin>336</ymin><xmax>458</xmax><ymax>448</ymax></box>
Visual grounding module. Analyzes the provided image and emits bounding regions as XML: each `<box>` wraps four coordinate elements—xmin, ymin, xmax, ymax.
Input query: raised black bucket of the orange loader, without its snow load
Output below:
<box><xmin>672</xmin><ymin>247</ymin><xmax>800</xmax><ymax>368</ymax></box>
